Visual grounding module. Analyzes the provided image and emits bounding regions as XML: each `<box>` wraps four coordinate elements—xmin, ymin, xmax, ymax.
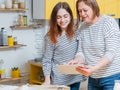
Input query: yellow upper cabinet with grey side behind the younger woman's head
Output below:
<box><xmin>32</xmin><ymin>0</ymin><xmax>76</xmax><ymax>19</ymax></box>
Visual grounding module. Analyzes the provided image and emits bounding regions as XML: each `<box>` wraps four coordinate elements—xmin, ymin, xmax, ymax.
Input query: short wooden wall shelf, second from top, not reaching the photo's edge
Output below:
<box><xmin>10</xmin><ymin>24</ymin><xmax>41</xmax><ymax>30</ymax></box>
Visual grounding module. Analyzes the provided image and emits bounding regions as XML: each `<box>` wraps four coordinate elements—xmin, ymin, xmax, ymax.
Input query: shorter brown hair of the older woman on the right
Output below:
<box><xmin>76</xmin><ymin>0</ymin><xmax>100</xmax><ymax>27</ymax></box>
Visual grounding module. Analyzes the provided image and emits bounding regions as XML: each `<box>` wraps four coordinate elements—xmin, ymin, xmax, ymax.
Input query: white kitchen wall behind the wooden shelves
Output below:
<box><xmin>0</xmin><ymin>0</ymin><xmax>46</xmax><ymax>77</ymax></box>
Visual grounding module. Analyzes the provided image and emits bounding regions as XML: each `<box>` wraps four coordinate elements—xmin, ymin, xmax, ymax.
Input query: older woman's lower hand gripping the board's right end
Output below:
<box><xmin>76</xmin><ymin>65</ymin><xmax>94</xmax><ymax>77</ymax></box>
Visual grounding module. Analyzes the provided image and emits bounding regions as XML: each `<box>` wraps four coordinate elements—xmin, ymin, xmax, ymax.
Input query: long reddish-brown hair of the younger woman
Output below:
<box><xmin>48</xmin><ymin>2</ymin><xmax>74</xmax><ymax>44</ymax></box>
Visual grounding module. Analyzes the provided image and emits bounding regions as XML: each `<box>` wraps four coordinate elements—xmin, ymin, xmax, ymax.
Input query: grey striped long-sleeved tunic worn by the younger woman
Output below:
<box><xmin>42</xmin><ymin>34</ymin><xmax>84</xmax><ymax>85</ymax></box>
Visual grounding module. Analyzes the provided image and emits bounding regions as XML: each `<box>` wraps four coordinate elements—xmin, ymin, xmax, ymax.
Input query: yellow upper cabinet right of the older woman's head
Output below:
<box><xmin>97</xmin><ymin>0</ymin><xmax>120</xmax><ymax>18</ymax></box>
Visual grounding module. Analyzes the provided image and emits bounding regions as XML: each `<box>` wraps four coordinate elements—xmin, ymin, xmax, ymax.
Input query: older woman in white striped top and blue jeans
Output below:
<box><xmin>69</xmin><ymin>0</ymin><xmax>120</xmax><ymax>90</ymax></box>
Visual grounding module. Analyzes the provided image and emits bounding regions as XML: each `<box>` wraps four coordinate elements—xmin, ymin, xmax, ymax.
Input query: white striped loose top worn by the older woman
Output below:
<box><xmin>77</xmin><ymin>15</ymin><xmax>120</xmax><ymax>78</ymax></box>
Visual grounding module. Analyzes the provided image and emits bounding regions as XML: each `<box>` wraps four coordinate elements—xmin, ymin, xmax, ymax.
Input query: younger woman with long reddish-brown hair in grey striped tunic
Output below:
<box><xmin>43</xmin><ymin>2</ymin><xmax>84</xmax><ymax>90</ymax></box>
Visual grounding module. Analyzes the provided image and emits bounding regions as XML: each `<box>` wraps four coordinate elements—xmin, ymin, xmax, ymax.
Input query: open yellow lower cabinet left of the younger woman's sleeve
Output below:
<box><xmin>29</xmin><ymin>61</ymin><xmax>44</xmax><ymax>84</ymax></box>
